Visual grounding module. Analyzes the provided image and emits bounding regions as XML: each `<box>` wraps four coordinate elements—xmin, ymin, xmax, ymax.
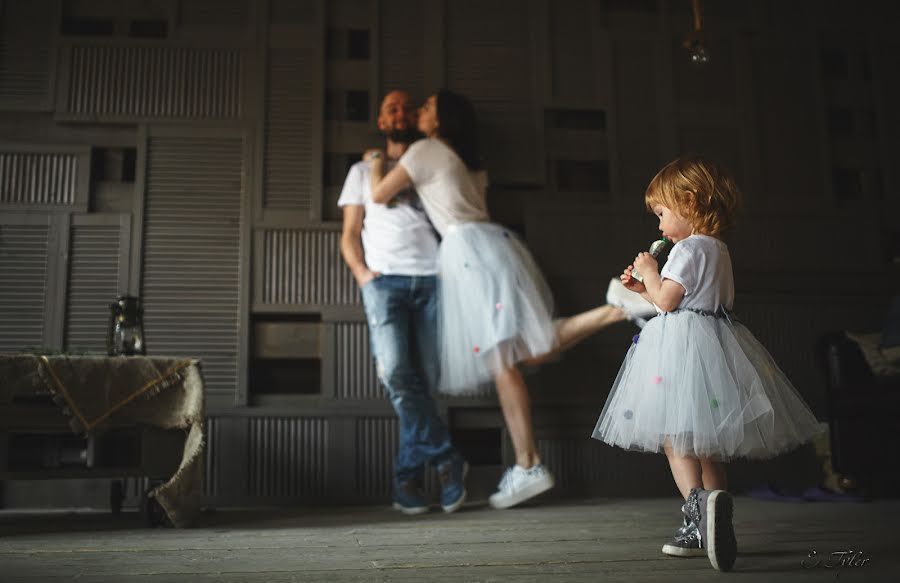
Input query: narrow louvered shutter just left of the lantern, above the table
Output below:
<box><xmin>64</xmin><ymin>225</ymin><xmax>123</xmax><ymax>353</ymax></box>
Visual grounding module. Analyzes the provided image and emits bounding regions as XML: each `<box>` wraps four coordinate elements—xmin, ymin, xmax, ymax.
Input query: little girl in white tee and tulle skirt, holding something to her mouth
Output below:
<box><xmin>593</xmin><ymin>156</ymin><xmax>819</xmax><ymax>571</ymax></box>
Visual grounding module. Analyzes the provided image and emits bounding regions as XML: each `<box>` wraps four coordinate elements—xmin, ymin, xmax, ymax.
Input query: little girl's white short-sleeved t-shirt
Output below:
<box><xmin>659</xmin><ymin>235</ymin><xmax>734</xmax><ymax>312</ymax></box>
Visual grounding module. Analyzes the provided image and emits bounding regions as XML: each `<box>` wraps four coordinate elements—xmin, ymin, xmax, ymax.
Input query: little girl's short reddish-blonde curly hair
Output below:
<box><xmin>644</xmin><ymin>154</ymin><xmax>741</xmax><ymax>237</ymax></box>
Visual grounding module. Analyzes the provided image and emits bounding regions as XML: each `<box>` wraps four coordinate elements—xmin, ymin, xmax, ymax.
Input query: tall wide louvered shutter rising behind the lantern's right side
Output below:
<box><xmin>143</xmin><ymin>137</ymin><xmax>243</xmax><ymax>394</ymax></box>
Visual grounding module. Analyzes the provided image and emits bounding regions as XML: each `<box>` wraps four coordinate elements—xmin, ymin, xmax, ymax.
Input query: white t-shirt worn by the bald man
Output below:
<box><xmin>338</xmin><ymin>162</ymin><xmax>438</xmax><ymax>275</ymax></box>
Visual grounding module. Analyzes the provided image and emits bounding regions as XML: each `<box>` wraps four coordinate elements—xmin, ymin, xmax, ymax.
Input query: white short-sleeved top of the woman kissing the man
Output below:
<box><xmin>399</xmin><ymin>138</ymin><xmax>488</xmax><ymax>236</ymax></box>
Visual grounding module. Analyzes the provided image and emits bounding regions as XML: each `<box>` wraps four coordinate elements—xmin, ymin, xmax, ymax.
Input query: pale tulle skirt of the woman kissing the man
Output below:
<box><xmin>438</xmin><ymin>223</ymin><xmax>556</xmax><ymax>395</ymax></box>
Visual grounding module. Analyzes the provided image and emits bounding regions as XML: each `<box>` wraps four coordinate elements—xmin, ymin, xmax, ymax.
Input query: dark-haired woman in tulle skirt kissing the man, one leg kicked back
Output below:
<box><xmin>364</xmin><ymin>90</ymin><xmax>626</xmax><ymax>508</ymax></box>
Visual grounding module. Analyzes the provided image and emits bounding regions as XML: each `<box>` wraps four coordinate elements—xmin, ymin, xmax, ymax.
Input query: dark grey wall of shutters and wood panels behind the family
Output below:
<box><xmin>0</xmin><ymin>0</ymin><xmax>900</xmax><ymax>503</ymax></box>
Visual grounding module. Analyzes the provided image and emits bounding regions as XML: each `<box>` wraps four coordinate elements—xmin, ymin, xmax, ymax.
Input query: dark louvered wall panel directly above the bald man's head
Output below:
<box><xmin>381</xmin><ymin>0</ymin><xmax>424</xmax><ymax>100</ymax></box>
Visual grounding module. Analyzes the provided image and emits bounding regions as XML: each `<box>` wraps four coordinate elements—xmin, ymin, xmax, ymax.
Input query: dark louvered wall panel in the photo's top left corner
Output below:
<box><xmin>0</xmin><ymin>0</ymin><xmax>56</xmax><ymax>104</ymax></box>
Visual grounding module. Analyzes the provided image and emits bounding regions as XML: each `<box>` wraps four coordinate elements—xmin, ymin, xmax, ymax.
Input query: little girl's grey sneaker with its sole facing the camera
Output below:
<box><xmin>685</xmin><ymin>488</ymin><xmax>737</xmax><ymax>571</ymax></box>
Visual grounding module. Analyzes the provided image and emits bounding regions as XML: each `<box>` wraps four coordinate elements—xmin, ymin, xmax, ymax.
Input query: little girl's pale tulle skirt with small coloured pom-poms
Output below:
<box><xmin>593</xmin><ymin>310</ymin><xmax>820</xmax><ymax>460</ymax></box>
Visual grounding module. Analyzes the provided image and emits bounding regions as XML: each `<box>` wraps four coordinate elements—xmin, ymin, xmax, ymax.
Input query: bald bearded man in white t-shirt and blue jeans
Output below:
<box><xmin>338</xmin><ymin>91</ymin><xmax>468</xmax><ymax>514</ymax></box>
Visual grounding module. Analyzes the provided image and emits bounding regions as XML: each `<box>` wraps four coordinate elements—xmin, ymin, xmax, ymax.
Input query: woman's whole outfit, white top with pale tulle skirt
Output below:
<box><xmin>399</xmin><ymin>138</ymin><xmax>556</xmax><ymax>395</ymax></box>
